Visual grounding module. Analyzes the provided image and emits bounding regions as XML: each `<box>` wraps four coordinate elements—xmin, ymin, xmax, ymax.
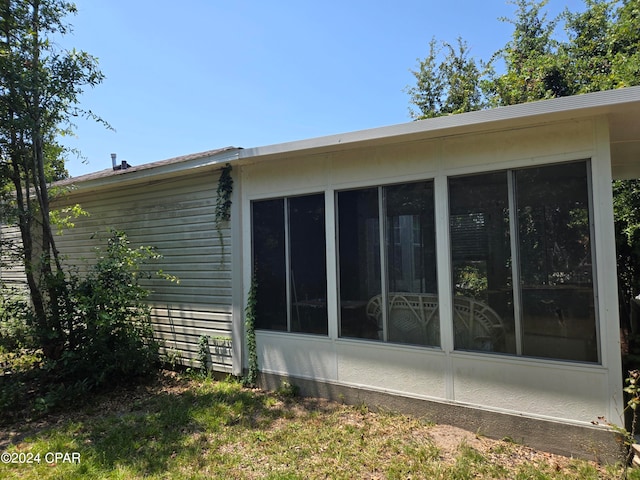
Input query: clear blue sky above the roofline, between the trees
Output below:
<box><xmin>57</xmin><ymin>0</ymin><xmax>584</xmax><ymax>176</ymax></box>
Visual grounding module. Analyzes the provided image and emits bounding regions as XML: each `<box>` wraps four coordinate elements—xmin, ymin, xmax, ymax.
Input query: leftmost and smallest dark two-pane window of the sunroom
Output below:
<box><xmin>252</xmin><ymin>194</ymin><xmax>328</xmax><ymax>335</ymax></box>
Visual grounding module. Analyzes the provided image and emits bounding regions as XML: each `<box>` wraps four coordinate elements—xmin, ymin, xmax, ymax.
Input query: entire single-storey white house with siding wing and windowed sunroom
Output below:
<box><xmin>48</xmin><ymin>87</ymin><xmax>640</xmax><ymax>462</ymax></box>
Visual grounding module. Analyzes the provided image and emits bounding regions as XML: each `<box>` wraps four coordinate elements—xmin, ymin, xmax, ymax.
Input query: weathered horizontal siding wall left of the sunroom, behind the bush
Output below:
<box><xmin>56</xmin><ymin>172</ymin><xmax>232</xmax><ymax>372</ymax></box>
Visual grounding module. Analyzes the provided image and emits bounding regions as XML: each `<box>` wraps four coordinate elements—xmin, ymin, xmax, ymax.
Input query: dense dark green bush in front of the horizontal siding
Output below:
<box><xmin>0</xmin><ymin>231</ymin><xmax>175</xmax><ymax>413</ymax></box>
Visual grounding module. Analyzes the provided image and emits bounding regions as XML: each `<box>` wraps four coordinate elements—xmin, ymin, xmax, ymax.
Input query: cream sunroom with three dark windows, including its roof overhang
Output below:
<box><xmin>240</xmin><ymin>88</ymin><xmax>640</xmax><ymax>458</ymax></box>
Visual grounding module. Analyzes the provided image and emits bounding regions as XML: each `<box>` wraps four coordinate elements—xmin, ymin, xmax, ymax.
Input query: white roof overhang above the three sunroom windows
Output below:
<box><xmin>239</xmin><ymin>86</ymin><xmax>640</xmax><ymax>177</ymax></box>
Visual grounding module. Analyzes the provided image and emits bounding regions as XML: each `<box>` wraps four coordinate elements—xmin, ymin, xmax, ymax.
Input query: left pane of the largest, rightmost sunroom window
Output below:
<box><xmin>449</xmin><ymin>172</ymin><xmax>516</xmax><ymax>353</ymax></box>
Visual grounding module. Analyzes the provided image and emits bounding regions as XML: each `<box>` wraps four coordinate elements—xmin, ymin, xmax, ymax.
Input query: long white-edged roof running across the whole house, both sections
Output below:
<box><xmin>58</xmin><ymin>86</ymin><xmax>640</xmax><ymax>187</ymax></box>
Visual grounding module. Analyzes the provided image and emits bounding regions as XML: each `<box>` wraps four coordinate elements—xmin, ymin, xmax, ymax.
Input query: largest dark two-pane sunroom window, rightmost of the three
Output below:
<box><xmin>449</xmin><ymin>162</ymin><xmax>598</xmax><ymax>362</ymax></box>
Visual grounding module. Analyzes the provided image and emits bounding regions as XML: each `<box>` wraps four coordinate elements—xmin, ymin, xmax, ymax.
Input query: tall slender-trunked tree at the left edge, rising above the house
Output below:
<box><xmin>0</xmin><ymin>0</ymin><xmax>103</xmax><ymax>356</ymax></box>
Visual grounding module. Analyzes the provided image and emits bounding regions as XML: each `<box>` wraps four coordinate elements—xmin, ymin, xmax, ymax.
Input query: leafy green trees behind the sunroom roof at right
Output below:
<box><xmin>406</xmin><ymin>0</ymin><xmax>640</xmax><ymax>338</ymax></box>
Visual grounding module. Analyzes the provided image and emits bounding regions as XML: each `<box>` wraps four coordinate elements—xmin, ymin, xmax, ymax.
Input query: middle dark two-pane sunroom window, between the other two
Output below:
<box><xmin>337</xmin><ymin>182</ymin><xmax>440</xmax><ymax>346</ymax></box>
